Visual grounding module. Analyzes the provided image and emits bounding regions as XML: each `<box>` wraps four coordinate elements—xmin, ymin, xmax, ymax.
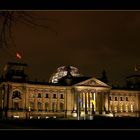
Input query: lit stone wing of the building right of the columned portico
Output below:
<box><xmin>109</xmin><ymin>89</ymin><xmax>140</xmax><ymax>116</ymax></box>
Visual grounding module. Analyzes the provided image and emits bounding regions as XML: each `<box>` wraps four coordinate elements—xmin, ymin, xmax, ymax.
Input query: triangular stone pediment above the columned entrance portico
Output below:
<box><xmin>75</xmin><ymin>77</ymin><xmax>110</xmax><ymax>88</ymax></box>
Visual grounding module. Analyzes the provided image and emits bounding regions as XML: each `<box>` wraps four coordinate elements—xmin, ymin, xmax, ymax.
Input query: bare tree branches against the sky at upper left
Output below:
<box><xmin>0</xmin><ymin>11</ymin><xmax>54</xmax><ymax>48</ymax></box>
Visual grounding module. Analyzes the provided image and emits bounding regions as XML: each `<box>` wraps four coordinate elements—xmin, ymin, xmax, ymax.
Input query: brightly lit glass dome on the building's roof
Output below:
<box><xmin>49</xmin><ymin>66</ymin><xmax>82</xmax><ymax>83</ymax></box>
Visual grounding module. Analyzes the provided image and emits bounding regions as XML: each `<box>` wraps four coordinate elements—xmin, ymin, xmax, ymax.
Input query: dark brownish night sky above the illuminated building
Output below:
<box><xmin>0</xmin><ymin>11</ymin><xmax>140</xmax><ymax>84</ymax></box>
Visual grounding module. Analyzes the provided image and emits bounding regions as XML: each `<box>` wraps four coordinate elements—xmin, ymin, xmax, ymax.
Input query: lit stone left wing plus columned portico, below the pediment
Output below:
<box><xmin>0</xmin><ymin>78</ymin><xmax>109</xmax><ymax>119</ymax></box>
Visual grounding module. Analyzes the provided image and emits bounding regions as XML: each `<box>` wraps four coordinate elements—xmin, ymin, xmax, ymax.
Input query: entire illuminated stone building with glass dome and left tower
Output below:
<box><xmin>0</xmin><ymin>63</ymin><xmax>140</xmax><ymax>119</ymax></box>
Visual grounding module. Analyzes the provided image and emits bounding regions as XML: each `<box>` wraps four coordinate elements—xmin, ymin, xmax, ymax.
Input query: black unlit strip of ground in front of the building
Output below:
<box><xmin>0</xmin><ymin>117</ymin><xmax>140</xmax><ymax>130</ymax></box>
